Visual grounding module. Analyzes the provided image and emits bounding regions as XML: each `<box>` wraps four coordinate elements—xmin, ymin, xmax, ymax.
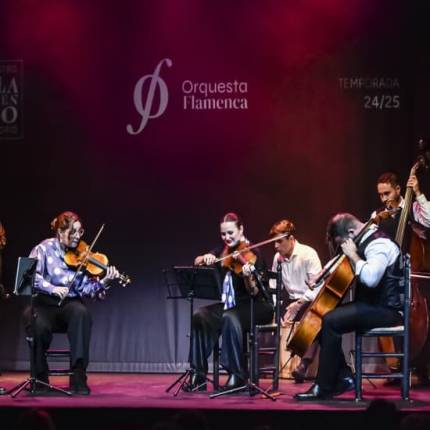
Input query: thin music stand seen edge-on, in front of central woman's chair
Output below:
<box><xmin>209</xmin><ymin>266</ymin><xmax>280</xmax><ymax>401</ymax></box>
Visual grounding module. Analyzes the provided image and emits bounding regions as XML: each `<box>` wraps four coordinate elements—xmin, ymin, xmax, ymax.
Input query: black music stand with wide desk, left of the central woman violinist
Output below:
<box><xmin>163</xmin><ymin>266</ymin><xmax>222</xmax><ymax>396</ymax></box>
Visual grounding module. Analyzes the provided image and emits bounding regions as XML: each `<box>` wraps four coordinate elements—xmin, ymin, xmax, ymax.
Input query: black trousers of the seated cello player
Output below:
<box><xmin>316</xmin><ymin>302</ymin><xmax>402</xmax><ymax>393</ymax></box>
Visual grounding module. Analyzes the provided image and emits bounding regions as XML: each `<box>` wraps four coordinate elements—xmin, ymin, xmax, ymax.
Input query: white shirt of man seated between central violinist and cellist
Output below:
<box><xmin>272</xmin><ymin>239</ymin><xmax>321</xmax><ymax>301</ymax></box>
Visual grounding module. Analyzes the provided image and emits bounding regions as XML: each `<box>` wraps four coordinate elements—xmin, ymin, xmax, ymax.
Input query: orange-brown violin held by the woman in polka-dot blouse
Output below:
<box><xmin>64</xmin><ymin>240</ymin><xmax>131</xmax><ymax>287</ymax></box>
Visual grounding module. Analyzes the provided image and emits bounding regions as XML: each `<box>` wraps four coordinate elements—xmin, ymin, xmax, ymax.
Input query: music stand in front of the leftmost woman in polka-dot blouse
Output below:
<box><xmin>8</xmin><ymin>257</ymin><xmax>72</xmax><ymax>397</ymax></box>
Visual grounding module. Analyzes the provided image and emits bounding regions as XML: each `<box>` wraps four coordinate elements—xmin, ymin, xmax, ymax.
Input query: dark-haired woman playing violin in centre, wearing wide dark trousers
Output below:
<box><xmin>188</xmin><ymin>213</ymin><xmax>273</xmax><ymax>391</ymax></box>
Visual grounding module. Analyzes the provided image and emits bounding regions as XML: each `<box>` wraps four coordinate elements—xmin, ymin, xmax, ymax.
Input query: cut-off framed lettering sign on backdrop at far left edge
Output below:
<box><xmin>0</xmin><ymin>60</ymin><xmax>23</xmax><ymax>139</ymax></box>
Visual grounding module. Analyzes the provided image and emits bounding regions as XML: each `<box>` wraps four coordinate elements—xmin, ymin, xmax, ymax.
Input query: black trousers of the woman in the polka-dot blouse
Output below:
<box><xmin>24</xmin><ymin>294</ymin><xmax>92</xmax><ymax>377</ymax></box>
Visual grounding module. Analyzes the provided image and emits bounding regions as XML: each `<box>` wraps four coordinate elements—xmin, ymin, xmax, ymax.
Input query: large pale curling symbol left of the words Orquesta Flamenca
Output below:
<box><xmin>127</xmin><ymin>58</ymin><xmax>173</xmax><ymax>135</ymax></box>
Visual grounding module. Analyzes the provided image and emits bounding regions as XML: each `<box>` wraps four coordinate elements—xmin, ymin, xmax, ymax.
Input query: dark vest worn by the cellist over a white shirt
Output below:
<box><xmin>355</xmin><ymin>230</ymin><xmax>403</xmax><ymax>309</ymax></box>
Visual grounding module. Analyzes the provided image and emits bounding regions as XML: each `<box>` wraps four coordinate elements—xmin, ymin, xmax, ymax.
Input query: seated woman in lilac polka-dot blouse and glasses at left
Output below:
<box><xmin>24</xmin><ymin>212</ymin><xmax>119</xmax><ymax>395</ymax></box>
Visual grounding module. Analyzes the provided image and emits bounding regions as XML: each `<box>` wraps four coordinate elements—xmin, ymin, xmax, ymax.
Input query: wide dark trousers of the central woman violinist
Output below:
<box><xmin>190</xmin><ymin>299</ymin><xmax>273</xmax><ymax>379</ymax></box>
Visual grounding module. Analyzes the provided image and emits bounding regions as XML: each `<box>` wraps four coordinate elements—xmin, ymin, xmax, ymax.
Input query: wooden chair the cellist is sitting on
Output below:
<box><xmin>354</xmin><ymin>254</ymin><xmax>411</xmax><ymax>401</ymax></box>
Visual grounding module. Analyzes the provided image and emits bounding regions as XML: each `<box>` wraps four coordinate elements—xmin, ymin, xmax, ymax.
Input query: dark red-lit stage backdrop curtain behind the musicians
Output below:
<box><xmin>0</xmin><ymin>0</ymin><xmax>430</xmax><ymax>371</ymax></box>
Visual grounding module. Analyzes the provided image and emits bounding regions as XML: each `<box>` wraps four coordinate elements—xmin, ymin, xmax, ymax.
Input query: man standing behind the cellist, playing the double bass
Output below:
<box><xmin>376</xmin><ymin>172</ymin><xmax>430</xmax><ymax>239</ymax></box>
